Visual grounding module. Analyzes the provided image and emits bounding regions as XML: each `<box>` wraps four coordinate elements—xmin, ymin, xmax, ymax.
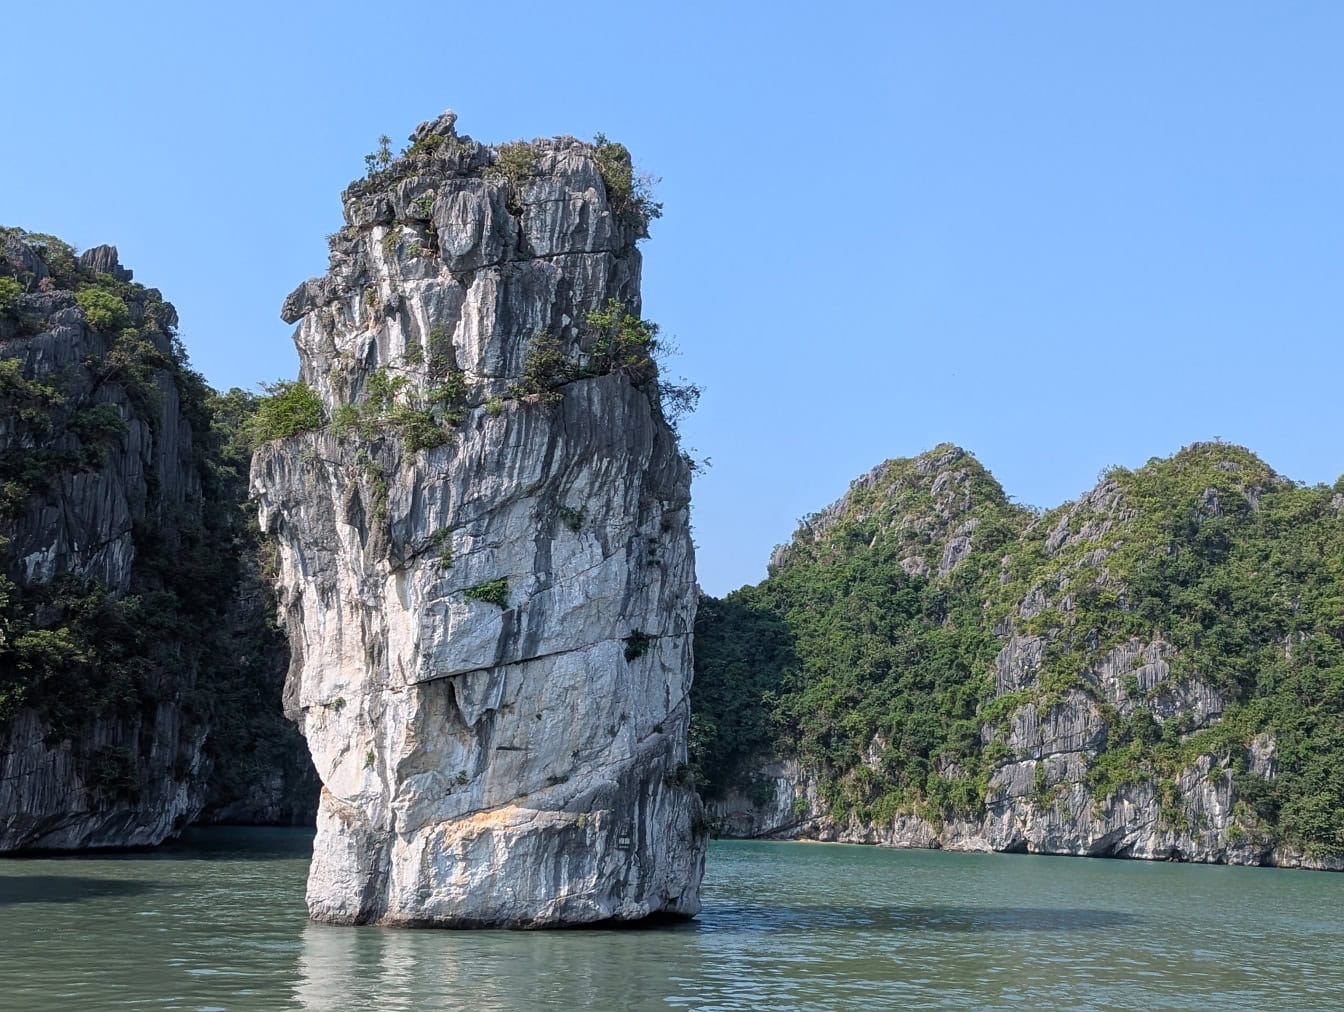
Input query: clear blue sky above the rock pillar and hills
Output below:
<box><xmin>0</xmin><ymin>0</ymin><xmax>1344</xmax><ymax>593</ymax></box>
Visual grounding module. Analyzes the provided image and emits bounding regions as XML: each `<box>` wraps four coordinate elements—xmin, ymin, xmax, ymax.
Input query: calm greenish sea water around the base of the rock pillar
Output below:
<box><xmin>0</xmin><ymin>829</ymin><xmax>1344</xmax><ymax>1012</ymax></box>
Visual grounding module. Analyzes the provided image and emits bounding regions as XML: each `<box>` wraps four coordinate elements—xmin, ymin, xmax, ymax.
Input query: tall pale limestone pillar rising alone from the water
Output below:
<box><xmin>253</xmin><ymin>114</ymin><xmax>706</xmax><ymax>926</ymax></box>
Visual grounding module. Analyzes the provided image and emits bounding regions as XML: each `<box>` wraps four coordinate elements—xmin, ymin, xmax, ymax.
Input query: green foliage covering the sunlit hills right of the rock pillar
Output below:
<box><xmin>692</xmin><ymin>444</ymin><xmax>1344</xmax><ymax>853</ymax></box>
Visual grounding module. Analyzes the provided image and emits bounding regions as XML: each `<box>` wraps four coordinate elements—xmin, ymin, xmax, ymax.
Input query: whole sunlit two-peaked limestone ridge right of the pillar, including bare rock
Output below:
<box><xmin>692</xmin><ymin>442</ymin><xmax>1344</xmax><ymax>867</ymax></box>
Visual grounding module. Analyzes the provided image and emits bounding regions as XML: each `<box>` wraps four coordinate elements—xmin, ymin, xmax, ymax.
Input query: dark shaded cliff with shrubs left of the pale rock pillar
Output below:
<box><xmin>0</xmin><ymin>228</ymin><xmax>317</xmax><ymax>851</ymax></box>
